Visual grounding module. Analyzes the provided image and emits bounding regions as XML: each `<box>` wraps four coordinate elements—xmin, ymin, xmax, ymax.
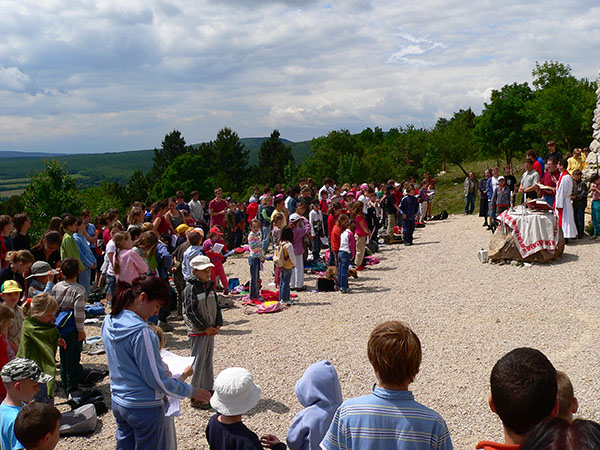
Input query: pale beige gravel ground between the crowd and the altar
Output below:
<box><xmin>57</xmin><ymin>216</ymin><xmax>600</xmax><ymax>449</ymax></box>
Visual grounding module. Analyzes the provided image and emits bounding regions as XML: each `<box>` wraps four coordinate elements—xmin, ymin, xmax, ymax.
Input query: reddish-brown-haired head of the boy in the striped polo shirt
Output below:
<box><xmin>367</xmin><ymin>321</ymin><xmax>423</xmax><ymax>386</ymax></box>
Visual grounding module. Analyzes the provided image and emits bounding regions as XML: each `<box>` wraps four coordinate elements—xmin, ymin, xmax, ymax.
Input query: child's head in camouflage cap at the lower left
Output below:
<box><xmin>0</xmin><ymin>358</ymin><xmax>52</xmax><ymax>404</ymax></box>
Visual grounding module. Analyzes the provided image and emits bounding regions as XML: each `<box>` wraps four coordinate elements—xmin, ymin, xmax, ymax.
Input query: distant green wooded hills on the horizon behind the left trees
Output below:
<box><xmin>0</xmin><ymin>137</ymin><xmax>310</xmax><ymax>199</ymax></box>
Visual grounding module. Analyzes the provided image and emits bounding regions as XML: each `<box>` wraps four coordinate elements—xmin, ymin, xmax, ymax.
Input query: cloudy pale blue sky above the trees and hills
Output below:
<box><xmin>0</xmin><ymin>0</ymin><xmax>600</xmax><ymax>153</ymax></box>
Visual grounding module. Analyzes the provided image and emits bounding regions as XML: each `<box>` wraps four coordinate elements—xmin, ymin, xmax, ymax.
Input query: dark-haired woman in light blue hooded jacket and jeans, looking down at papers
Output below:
<box><xmin>102</xmin><ymin>275</ymin><xmax>210</xmax><ymax>450</ymax></box>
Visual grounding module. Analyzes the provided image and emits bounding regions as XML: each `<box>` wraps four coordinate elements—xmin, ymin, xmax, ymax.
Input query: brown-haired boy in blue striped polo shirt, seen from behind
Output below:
<box><xmin>321</xmin><ymin>321</ymin><xmax>452</xmax><ymax>450</ymax></box>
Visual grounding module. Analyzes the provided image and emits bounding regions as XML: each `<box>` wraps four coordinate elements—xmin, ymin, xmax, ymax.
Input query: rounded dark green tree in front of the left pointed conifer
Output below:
<box><xmin>150</xmin><ymin>152</ymin><xmax>217</xmax><ymax>200</ymax></box>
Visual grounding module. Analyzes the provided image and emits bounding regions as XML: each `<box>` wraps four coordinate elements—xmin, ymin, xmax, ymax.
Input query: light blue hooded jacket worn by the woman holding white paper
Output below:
<box><xmin>102</xmin><ymin>309</ymin><xmax>194</xmax><ymax>408</ymax></box>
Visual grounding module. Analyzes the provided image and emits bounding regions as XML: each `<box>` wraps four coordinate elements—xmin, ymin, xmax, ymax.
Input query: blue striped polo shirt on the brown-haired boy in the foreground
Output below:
<box><xmin>321</xmin><ymin>388</ymin><xmax>452</xmax><ymax>450</ymax></box>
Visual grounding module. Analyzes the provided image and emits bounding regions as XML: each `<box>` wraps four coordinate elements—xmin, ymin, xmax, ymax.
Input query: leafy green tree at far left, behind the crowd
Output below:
<box><xmin>23</xmin><ymin>160</ymin><xmax>83</xmax><ymax>240</ymax></box>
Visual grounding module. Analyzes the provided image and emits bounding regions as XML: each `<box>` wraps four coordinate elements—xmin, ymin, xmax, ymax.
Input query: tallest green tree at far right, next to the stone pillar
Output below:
<box><xmin>527</xmin><ymin>61</ymin><xmax>596</xmax><ymax>151</ymax></box>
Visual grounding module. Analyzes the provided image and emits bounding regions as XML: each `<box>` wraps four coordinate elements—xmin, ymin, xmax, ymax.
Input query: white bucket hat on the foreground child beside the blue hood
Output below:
<box><xmin>210</xmin><ymin>367</ymin><xmax>261</xmax><ymax>416</ymax></box>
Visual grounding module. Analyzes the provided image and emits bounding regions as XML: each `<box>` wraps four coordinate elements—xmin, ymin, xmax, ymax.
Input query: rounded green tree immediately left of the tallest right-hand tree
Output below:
<box><xmin>475</xmin><ymin>83</ymin><xmax>533</xmax><ymax>164</ymax></box>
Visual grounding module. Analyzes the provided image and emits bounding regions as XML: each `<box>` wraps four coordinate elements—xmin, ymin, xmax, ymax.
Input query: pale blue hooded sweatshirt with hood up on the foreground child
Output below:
<box><xmin>287</xmin><ymin>360</ymin><xmax>342</xmax><ymax>450</ymax></box>
